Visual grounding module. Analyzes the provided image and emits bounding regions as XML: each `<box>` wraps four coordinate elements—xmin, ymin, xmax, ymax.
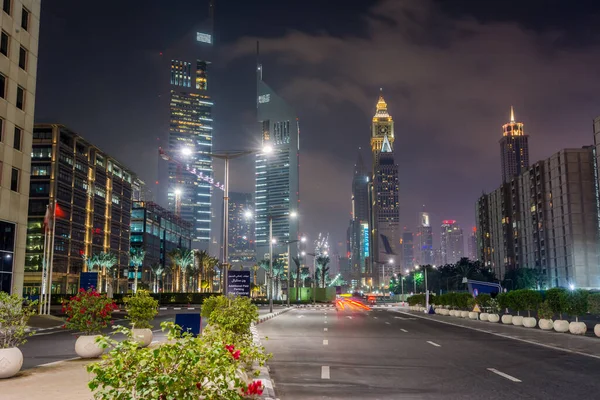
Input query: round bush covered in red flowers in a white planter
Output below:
<box><xmin>63</xmin><ymin>288</ymin><xmax>118</xmax><ymax>335</ymax></box>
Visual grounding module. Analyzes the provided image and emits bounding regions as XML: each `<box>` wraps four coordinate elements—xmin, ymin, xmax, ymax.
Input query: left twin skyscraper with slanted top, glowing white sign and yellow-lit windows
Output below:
<box><xmin>167</xmin><ymin>7</ymin><xmax>213</xmax><ymax>249</ymax></box>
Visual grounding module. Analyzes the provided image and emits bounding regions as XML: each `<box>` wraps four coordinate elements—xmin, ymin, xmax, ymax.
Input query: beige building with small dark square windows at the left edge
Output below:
<box><xmin>0</xmin><ymin>0</ymin><xmax>41</xmax><ymax>294</ymax></box>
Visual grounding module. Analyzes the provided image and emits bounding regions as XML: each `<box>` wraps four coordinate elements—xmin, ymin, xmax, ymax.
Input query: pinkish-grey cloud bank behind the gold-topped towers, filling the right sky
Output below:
<box><xmin>223</xmin><ymin>0</ymin><xmax>600</xmax><ymax>245</ymax></box>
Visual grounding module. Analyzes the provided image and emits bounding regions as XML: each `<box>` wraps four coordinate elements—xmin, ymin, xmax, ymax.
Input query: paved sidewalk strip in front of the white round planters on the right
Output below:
<box><xmin>393</xmin><ymin>308</ymin><xmax>600</xmax><ymax>359</ymax></box>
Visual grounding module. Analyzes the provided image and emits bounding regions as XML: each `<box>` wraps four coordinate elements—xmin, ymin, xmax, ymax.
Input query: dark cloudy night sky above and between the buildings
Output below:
<box><xmin>36</xmin><ymin>0</ymin><xmax>600</xmax><ymax>251</ymax></box>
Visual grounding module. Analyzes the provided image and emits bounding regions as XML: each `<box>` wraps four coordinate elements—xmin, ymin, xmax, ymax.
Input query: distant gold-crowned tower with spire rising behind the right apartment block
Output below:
<box><xmin>500</xmin><ymin>106</ymin><xmax>529</xmax><ymax>182</ymax></box>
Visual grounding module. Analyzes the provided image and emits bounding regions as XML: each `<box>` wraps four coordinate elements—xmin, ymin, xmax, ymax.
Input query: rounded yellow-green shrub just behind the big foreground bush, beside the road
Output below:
<box><xmin>202</xmin><ymin>296</ymin><xmax>258</xmax><ymax>334</ymax></box>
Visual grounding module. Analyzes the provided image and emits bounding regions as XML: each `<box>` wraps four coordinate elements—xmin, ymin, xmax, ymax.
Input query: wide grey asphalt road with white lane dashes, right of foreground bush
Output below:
<box><xmin>259</xmin><ymin>308</ymin><xmax>600</xmax><ymax>400</ymax></box>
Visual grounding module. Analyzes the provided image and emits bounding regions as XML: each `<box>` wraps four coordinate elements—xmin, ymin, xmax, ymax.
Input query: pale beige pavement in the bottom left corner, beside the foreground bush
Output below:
<box><xmin>0</xmin><ymin>360</ymin><xmax>98</xmax><ymax>400</ymax></box>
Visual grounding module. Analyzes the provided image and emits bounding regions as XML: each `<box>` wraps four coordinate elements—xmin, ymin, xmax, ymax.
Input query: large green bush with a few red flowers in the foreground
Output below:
<box><xmin>87</xmin><ymin>322</ymin><xmax>266</xmax><ymax>400</ymax></box>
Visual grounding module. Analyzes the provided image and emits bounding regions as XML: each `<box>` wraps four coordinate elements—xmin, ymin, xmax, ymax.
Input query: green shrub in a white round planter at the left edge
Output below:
<box><xmin>0</xmin><ymin>291</ymin><xmax>37</xmax><ymax>349</ymax></box>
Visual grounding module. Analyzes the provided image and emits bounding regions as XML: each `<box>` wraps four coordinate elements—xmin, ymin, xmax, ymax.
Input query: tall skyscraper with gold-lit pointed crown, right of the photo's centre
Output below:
<box><xmin>371</xmin><ymin>94</ymin><xmax>400</xmax><ymax>275</ymax></box>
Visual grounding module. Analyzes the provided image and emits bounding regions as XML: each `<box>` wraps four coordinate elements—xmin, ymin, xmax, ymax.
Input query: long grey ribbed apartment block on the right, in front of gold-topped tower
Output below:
<box><xmin>477</xmin><ymin>146</ymin><xmax>600</xmax><ymax>288</ymax></box>
